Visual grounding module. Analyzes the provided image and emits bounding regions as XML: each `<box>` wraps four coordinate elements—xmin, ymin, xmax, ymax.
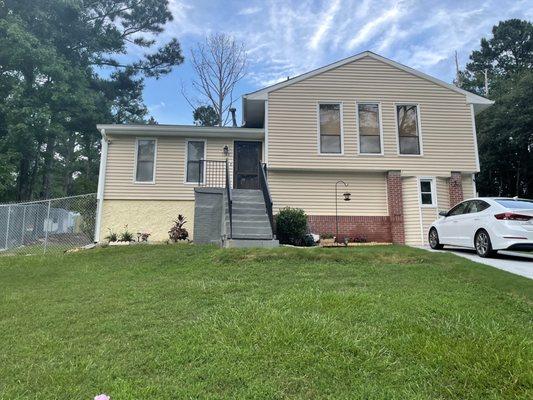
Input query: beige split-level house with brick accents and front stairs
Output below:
<box><xmin>93</xmin><ymin>51</ymin><xmax>492</xmax><ymax>245</ymax></box>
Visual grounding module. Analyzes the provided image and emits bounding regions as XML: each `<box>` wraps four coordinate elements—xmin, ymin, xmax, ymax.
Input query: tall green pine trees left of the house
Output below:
<box><xmin>0</xmin><ymin>0</ymin><xmax>183</xmax><ymax>202</ymax></box>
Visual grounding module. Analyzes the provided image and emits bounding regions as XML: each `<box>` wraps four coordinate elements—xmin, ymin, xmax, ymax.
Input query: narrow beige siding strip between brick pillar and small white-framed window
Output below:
<box><xmin>402</xmin><ymin>176</ymin><xmax>421</xmax><ymax>245</ymax></box>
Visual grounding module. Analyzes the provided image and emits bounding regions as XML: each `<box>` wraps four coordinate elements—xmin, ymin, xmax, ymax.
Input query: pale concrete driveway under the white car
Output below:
<box><xmin>422</xmin><ymin>246</ymin><xmax>533</xmax><ymax>279</ymax></box>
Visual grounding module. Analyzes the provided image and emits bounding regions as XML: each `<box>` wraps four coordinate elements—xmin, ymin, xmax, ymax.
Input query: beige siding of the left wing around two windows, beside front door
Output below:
<box><xmin>104</xmin><ymin>135</ymin><xmax>239</xmax><ymax>200</ymax></box>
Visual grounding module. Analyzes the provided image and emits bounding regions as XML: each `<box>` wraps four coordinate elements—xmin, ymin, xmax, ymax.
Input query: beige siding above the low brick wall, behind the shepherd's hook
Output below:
<box><xmin>268</xmin><ymin>171</ymin><xmax>388</xmax><ymax>216</ymax></box>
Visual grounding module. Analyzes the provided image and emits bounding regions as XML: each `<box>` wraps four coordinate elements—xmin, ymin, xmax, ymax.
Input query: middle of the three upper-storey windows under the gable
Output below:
<box><xmin>357</xmin><ymin>104</ymin><xmax>382</xmax><ymax>154</ymax></box>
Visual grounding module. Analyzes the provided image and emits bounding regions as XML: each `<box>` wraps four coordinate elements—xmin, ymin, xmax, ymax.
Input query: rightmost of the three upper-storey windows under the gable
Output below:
<box><xmin>396</xmin><ymin>104</ymin><xmax>420</xmax><ymax>155</ymax></box>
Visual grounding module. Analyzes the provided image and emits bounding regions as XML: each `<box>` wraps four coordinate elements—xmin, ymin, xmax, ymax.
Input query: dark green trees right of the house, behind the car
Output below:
<box><xmin>460</xmin><ymin>19</ymin><xmax>533</xmax><ymax>197</ymax></box>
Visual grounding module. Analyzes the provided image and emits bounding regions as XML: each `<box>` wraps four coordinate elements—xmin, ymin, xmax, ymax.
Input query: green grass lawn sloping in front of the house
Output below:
<box><xmin>0</xmin><ymin>245</ymin><xmax>533</xmax><ymax>400</ymax></box>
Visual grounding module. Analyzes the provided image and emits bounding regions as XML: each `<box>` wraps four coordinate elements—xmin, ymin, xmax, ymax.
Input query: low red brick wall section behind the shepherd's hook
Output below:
<box><xmin>307</xmin><ymin>215</ymin><xmax>392</xmax><ymax>243</ymax></box>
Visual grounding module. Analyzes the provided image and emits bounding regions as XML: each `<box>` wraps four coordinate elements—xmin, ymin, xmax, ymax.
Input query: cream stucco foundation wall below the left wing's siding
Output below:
<box><xmin>100</xmin><ymin>200</ymin><xmax>194</xmax><ymax>242</ymax></box>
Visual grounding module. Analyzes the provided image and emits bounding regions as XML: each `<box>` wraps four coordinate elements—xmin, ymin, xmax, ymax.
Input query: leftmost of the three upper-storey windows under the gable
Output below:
<box><xmin>318</xmin><ymin>104</ymin><xmax>342</xmax><ymax>154</ymax></box>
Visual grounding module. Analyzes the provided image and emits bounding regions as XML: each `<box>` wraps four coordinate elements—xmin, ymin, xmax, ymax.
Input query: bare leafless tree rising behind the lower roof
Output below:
<box><xmin>183</xmin><ymin>33</ymin><xmax>247</xmax><ymax>126</ymax></box>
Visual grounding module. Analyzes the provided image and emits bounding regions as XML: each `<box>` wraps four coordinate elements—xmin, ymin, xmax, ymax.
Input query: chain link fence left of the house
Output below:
<box><xmin>0</xmin><ymin>193</ymin><xmax>97</xmax><ymax>255</ymax></box>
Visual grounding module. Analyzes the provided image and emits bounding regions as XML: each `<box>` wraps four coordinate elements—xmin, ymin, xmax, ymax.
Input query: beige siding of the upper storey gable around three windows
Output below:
<box><xmin>268</xmin><ymin>57</ymin><xmax>476</xmax><ymax>175</ymax></box>
